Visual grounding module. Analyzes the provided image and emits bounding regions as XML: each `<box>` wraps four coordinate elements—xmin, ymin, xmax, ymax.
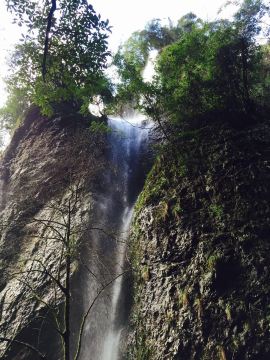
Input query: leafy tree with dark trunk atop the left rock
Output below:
<box><xmin>1</xmin><ymin>0</ymin><xmax>110</xmax><ymax>120</ymax></box>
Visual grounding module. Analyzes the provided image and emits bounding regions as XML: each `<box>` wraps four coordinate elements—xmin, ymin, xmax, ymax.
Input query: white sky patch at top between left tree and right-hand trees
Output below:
<box><xmin>90</xmin><ymin>0</ymin><xmax>237</xmax><ymax>50</ymax></box>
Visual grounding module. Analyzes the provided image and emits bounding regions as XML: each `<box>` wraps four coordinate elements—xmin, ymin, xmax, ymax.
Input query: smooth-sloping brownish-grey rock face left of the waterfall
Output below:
<box><xmin>0</xmin><ymin>108</ymin><xmax>104</xmax><ymax>360</ymax></box>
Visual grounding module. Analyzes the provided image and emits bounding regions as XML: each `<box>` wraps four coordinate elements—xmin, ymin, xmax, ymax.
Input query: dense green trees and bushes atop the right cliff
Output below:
<box><xmin>115</xmin><ymin>0</ymin><xmax>270</xmax><ymax>139</ymax></box>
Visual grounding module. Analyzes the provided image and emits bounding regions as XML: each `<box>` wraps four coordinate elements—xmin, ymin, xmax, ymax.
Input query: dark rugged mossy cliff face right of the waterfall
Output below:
<box><xmin>130</xmin><ymin>117</ymin><xmax>270</xmax><ymax>360</ymax></box>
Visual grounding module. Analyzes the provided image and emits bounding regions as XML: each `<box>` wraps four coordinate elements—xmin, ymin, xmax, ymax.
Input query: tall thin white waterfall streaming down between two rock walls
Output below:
<box><xmin>73</xmin><ymin>115</ymin><xmax>150</xmax><ymax>360</ymax></box>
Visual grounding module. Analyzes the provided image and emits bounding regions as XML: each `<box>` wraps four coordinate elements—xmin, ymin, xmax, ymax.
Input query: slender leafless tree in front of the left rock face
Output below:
<box><xmin>0</xmin><ymin>190</ymin><xmax>123</xmax><ymax>360</ymax></box>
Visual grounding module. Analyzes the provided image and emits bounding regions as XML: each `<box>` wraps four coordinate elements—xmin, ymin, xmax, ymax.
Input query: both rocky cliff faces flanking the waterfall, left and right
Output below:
<box><xmin>0</xmin><ymin>108</ymin><xmax>270</xmax><ymax>360</ymax></box>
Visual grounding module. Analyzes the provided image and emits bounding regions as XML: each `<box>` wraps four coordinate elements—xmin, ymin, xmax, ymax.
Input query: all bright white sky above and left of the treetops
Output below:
<box><xmin>0</xmin><ymin>0</ymin><xmax>238</xmax><ymax>106</ymax></box>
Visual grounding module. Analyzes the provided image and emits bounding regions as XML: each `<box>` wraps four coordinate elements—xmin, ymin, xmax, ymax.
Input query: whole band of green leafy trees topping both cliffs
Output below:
<box><xmin>1</xmin><ymin>0</ymin><xmax>270</xmax><ymax>139</ymax></box>
